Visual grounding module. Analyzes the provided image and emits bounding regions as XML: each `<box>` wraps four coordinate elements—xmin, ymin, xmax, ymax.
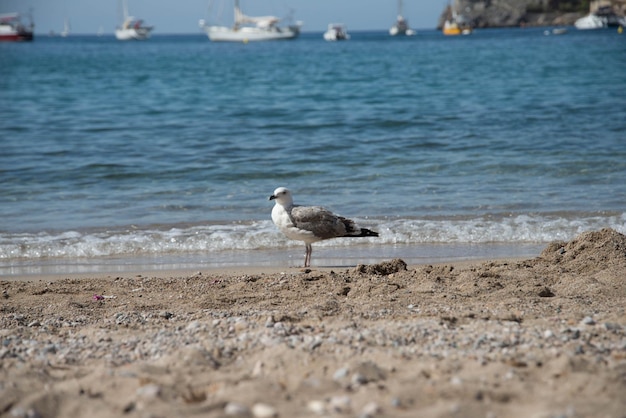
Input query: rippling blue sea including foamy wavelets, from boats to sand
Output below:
<box><xmin>0</xmin><ymin>28</ymin><xmax>626</xmax><ymax>275</ymax></box>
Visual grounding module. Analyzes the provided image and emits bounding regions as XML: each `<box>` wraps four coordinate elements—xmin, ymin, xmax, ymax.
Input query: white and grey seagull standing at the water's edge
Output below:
<box><xmin>269</xmin><ymin>187</ymin><xmax>378</xmax><ymax>267</ymax></box>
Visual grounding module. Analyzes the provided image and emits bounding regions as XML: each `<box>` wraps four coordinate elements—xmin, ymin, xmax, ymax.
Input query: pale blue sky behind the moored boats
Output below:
<box><xmin>0</xmin><ymin>0</ymin><xmax>447</xmax><ymax>34</ymax></box>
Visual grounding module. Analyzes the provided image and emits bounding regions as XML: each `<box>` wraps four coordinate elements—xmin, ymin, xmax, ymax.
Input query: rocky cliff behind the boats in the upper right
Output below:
<box><xmin>437</xmin><ymin>0</ymin><xmax>626</xmax><ymax>28</ymax></box>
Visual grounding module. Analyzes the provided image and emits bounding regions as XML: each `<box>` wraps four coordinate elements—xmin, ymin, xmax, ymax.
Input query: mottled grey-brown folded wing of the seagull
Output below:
<box><xmin>291</xmin><ymin>206</ymin><xmax>352</xmax><ymax>239</ymax></box>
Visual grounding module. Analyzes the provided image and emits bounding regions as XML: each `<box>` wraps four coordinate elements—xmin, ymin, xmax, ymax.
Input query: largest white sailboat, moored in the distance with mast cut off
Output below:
<box><xmin>199</xmin><ymin>0</ymin><xmax>302</xmax><ymax>43</ymax></box>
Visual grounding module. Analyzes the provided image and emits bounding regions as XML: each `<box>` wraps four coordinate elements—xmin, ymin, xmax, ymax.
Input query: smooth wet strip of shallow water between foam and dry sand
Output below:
<box><xmin>0</xmin><ymin>243</ymin><xmax>546</xmax><ymax>280</ymax></box>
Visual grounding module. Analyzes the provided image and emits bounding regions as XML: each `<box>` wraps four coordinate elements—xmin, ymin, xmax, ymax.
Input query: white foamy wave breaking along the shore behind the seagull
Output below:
<box><xmin>0</xmin><ymin>213</ymin><xmax>626</xmax><ymax>263</ymax></box>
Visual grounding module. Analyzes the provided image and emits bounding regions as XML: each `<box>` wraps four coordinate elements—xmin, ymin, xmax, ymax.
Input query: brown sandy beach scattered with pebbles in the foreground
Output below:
<box><xmin>0</xmin><ymin>229</ymin><xmax>626</xmax><ymax>418</ymax></box>
